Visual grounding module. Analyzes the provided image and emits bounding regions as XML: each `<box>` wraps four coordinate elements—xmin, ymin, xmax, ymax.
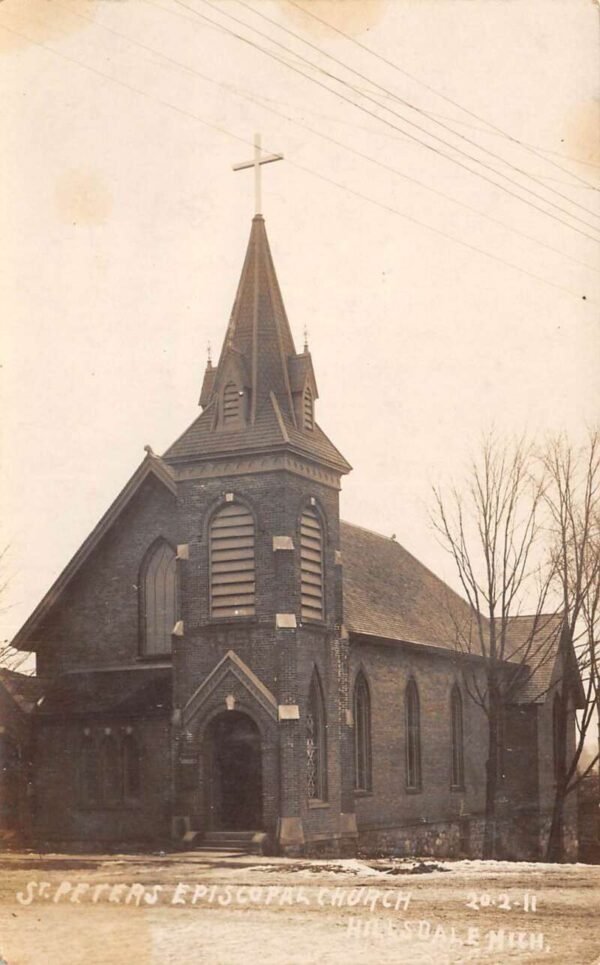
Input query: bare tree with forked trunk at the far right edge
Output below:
<box><xmin>543</xmin><ymin>429</ymin><xmax>600</xmax><ymax>861</ymax></box>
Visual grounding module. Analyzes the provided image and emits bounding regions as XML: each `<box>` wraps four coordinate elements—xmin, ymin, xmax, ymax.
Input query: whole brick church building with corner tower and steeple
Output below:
<box><xmin>0</xmin><ymin>145</ymin><xmax>578</xmax><ymax>857</ymax></box>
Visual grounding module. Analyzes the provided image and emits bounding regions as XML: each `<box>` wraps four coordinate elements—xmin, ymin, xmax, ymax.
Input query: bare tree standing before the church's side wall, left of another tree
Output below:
<box><xmin>432</xmin><ymin>435</ymin><xmax>555</xmax><ymax>858</ymax></box>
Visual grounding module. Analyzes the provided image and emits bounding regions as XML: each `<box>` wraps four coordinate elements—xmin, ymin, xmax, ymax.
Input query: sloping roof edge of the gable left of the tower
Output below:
<box><xmin>11</xmin><ymin>448</ymin><xmax>176</xmax><ymax>650</ymax></box>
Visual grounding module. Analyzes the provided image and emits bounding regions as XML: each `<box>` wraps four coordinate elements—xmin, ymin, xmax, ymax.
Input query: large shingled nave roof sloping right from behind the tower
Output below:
<box><xmin>340</xmin><ymin>522</ymin><xmax>473</xmax><ymax>652</ymax></box>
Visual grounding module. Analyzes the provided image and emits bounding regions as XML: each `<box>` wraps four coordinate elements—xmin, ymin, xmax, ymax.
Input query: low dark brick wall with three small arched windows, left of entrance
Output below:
<box><xmin>33</xmin><ymin>717</ymin><xmax>171</xmax><ymax>849</ymax></box>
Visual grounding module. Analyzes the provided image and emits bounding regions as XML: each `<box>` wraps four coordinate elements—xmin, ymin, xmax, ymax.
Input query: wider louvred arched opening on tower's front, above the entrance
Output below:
<box><xmin>210</xmin><ymin>503</ymin><xmax>256</xmax><ymax>617</ymax></box>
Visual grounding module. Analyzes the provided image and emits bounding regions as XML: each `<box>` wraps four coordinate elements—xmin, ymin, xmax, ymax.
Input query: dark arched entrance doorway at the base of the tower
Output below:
<box><xmin>203</xmin><ymin>710</ymin><xmax>264</xmax><ymax>831</ymax></box>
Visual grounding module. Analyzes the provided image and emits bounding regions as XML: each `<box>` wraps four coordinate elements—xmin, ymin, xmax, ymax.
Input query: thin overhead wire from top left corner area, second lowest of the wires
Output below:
<box><xmin>48</xmin><ymin>0</ymin><xmax>599</xmax><ymax>273</ymax></box>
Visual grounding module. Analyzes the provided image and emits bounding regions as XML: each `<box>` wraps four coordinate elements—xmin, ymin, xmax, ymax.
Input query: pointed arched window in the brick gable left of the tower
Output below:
<box><xmin>140</xmin><ymin>540</ymin><xmax>177</xmax><ymax>657</ymax></box>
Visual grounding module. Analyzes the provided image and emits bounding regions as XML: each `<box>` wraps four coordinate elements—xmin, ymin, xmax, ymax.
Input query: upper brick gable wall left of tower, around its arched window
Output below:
<box><xmin>37</xmin><ymin>478</ymin><xmax>178</xmax><ymax>677</ymax></box>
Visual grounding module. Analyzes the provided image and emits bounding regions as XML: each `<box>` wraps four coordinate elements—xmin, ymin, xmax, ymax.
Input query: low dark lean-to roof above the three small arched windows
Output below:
<box><xmin>37</xmin><ymin>666</ymin><xmax>173</xmax><ymax>717</ymax></box>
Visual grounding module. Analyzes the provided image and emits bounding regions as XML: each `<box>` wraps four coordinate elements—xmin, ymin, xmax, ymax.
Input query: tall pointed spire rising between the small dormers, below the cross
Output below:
<box><xmin>213</xmin><ymin>215</ymin><xmax>296</xmax><ymax>423</ymax></box>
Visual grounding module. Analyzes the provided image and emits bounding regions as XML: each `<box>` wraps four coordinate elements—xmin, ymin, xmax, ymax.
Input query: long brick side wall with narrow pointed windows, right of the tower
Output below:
<box><xmin>350</xmin><ymin>642</ymin><xmax>487</xmax><ymax>856</ymax></box>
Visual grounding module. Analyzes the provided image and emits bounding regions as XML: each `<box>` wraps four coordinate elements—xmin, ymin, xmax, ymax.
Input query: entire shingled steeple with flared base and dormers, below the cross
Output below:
<box><xmin>164</xmin><ymin>214</ymin><xmax>350</xmax><ymax>473</ymax></box>
